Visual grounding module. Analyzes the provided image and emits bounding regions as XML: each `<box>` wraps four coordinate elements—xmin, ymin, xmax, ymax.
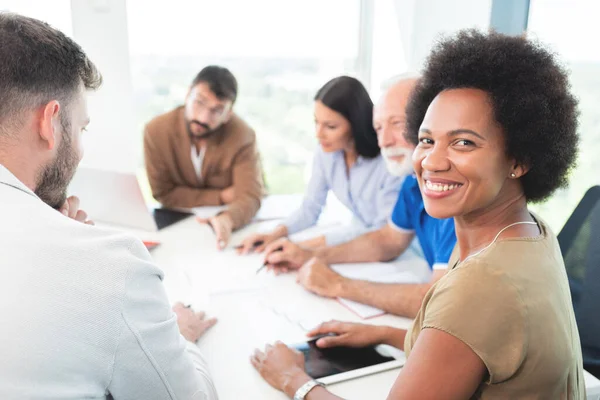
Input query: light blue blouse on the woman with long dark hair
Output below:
<box><xmin>284</xmin><ymin>149</ymin><xmax>403</xmax><ymax>246</ymax></box>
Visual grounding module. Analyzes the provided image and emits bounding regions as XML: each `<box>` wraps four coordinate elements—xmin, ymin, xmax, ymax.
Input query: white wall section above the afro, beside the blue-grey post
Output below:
<box><xmin>395</xmin><ymin>0</ymin><xmax>492</xmax><ymax>71</ymax></box>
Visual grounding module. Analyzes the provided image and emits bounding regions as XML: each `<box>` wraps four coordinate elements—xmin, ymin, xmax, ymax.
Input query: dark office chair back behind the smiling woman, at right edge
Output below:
<box><xmin>558</xmin><ymin>186</ymin><xmax>600</xmax><ymax>379</ymax></box>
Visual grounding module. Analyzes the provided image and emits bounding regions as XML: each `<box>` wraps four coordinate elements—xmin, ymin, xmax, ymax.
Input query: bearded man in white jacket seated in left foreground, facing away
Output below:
<box><xmin>0</xmin><ymin>13</ymin><xmax>217</xmax><ymax>400</ymax></box>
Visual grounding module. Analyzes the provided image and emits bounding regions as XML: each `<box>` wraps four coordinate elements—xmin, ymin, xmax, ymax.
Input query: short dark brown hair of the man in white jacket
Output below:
<box><xmin>0</xmin><ymin>12</ymin><xmax>102</xmax><ymax>133</ymax></box>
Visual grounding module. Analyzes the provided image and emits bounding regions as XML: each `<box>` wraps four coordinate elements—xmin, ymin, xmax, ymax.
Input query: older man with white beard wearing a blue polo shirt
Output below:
<box><xmin>265</xmin><ymin>75</ymin><xmax>456</xmax><ymax>317</ymax></box>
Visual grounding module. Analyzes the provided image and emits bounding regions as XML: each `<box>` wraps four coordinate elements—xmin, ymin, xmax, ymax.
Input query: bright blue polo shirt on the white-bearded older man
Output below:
<box><xmin>390</xmin><ymin>175</ymin><xmax>456</xmax><ymax>269</ymax></box>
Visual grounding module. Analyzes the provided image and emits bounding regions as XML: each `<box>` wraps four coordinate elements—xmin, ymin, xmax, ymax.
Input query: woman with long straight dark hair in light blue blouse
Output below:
<box><xmin>240</xmin><ymin>76</ymin><xmax>402</xmax><ymax>253</ymax></box>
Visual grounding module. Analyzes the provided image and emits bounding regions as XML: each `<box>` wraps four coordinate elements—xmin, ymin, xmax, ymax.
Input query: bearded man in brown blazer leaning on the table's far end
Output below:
<box><xmin>144</xmin><ymin>66</ymin><xmax>264</xmax><ymax>248</ymax></box>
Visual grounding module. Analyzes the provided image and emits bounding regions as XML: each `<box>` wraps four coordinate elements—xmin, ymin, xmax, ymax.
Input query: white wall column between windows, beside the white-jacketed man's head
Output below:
<box><xmin>71</xmin><ymin>0</ymin><xmax>137</xmax><ymax>171</ymax></box>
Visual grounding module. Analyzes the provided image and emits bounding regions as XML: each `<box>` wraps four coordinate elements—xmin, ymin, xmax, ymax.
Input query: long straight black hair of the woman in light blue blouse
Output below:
<box><xmin>315</xmin><ymin>76</ymin><xmax>380</xmax><ymax>158</ymax></box>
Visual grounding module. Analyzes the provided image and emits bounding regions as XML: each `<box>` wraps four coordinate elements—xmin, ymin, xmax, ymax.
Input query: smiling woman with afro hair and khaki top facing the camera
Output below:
<box><xmin>400</xmin><ymin>30</ymin><xmax>585</xmax><ymax>399</ymax></box>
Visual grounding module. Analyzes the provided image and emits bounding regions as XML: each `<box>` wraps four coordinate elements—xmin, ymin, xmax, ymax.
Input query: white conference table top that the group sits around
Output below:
<box><xmin>136</xmin><ymin>218</ymin><xmax>600</xmax><ymax>400</ymax></box>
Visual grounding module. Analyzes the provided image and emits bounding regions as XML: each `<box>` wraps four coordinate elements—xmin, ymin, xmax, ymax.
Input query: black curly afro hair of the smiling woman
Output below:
<box><xmin>406</xmin><ymin>30</ymin><xmax>579</xmax><ymax>201</ymax></box>
